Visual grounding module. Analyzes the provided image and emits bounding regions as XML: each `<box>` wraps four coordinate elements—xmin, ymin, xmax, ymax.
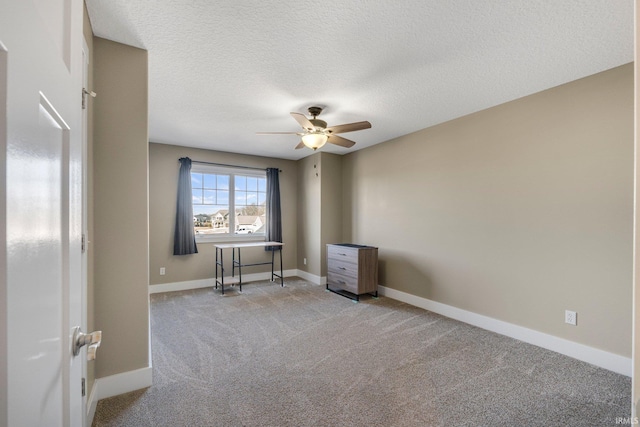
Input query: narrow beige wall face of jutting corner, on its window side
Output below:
<box><xmin>297</xmin><ymin>153</ymin><xmax>322</xmax><ymax>276</ymax></box>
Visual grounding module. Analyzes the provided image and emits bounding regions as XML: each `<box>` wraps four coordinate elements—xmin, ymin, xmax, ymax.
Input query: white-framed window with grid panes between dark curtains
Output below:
<box><xmin>191</xmin><ymin>165</ymin><xmax>267</xmax><ymax>240</ymax></box>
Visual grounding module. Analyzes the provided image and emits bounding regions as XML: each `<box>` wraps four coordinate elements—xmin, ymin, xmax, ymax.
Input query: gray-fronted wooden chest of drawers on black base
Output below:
<box><xmin>327</xmin><ymin>243</ymin><xmax>378</xmax><ymax>300</ymax></box>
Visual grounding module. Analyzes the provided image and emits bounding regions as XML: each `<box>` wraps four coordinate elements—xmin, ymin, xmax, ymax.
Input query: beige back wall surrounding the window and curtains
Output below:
<box><xmin>149</xmin><ymin>143</ymin><xmax>298</xmax><ymax>286</ymax></box>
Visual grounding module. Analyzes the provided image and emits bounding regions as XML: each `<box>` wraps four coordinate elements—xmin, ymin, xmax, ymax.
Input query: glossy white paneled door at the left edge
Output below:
<box><xmin>0</xmin><ymin>0</ymin><xmax>86</xmax><ymax>426</ymax></box>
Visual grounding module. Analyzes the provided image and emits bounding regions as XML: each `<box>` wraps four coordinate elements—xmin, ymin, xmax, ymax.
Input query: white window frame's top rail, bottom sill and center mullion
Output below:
<box><xmin>191</xmin><ymin>164</ymin><xmax>268</xmax><ymax>243</ymax></box>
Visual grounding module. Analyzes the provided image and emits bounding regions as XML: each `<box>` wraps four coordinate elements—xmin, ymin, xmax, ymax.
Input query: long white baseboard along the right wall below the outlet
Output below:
<box><xmin>378</xmin><ymin>286</ymin><xmax>632</xmax><ymax>377</ymax></box>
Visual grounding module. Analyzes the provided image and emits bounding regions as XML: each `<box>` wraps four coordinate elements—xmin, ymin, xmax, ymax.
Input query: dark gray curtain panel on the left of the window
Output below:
<box><xmin>173</xmin><ymin>157</ymin><xmax>198</xmax><ymax>255</ymax></box>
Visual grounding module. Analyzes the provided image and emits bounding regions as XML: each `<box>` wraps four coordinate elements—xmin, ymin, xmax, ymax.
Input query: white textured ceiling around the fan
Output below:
<box><xmin>86</xmin><ymin>0</ymin><xmax>634</xmax><ymax>159</ymax></box>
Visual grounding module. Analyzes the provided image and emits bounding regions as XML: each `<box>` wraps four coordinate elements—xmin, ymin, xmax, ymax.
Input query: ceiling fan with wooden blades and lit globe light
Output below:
<box><xmin>258</xmin><ymin>107</ymin><xmax>371</xmax><ymax>151</ymax></box>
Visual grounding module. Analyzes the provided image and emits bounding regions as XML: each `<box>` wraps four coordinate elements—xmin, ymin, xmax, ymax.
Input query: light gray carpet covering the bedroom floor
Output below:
<box><xmin>93</xmin><ymin>279</ymin><xmax>631</xmax><ymax>427</ymax></box>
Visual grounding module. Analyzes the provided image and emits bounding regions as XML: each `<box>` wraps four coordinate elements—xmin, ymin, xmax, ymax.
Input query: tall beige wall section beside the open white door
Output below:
<box><xmin>93</xmin><ymin>38</ymin><xmax>149</xmax><ymax>378</ymax></box>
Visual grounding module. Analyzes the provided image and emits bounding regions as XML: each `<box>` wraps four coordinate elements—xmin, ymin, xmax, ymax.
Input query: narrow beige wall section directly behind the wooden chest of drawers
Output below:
<box><xmin>320</xmin><ymin>152</ymin><xmax>343</xmax><ymax>276</ymax></box>
